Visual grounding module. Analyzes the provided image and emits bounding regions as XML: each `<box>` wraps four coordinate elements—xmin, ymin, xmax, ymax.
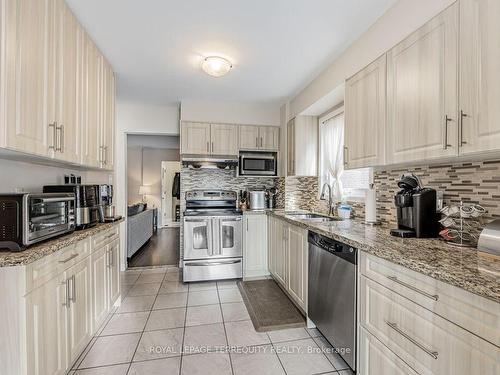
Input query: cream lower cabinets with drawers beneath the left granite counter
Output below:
<box><xmin>0</xmin><ymin>226</ymin><xmax>120</xmax><ymax>375</ymax></box>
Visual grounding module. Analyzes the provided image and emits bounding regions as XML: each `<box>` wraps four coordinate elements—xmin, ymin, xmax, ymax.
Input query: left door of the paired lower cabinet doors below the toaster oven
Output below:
<box><xmin>26</xmin><ymin>278</ymin><xmax>68</xmax><ymax>375</ymax></box>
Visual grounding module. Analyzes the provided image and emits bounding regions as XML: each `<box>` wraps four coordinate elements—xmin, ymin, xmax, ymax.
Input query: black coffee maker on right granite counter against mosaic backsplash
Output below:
<box><xmin>391</xmin><ymin>174</ymin><xmax>438</xmax><ymax>238</ymax></box>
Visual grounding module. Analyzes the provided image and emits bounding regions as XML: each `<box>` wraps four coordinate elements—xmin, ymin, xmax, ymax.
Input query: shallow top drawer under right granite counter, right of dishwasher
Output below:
<box><xmin>360</xmin><ymin>253</ymin><xmax>500</xmax><ymax>346</ymax></box>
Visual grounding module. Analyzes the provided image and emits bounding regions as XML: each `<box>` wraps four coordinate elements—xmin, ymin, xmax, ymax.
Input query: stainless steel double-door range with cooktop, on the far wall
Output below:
<box><xmin>183</xmin><ymin>190</ymin><xmax>243</xmax><ymax>282</ymax></box>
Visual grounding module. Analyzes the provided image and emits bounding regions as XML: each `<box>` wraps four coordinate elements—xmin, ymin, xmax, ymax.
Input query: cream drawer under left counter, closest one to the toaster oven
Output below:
<box><xmin>26</xmin><ymin>239</ymin><xmax>90</xmax><ymax>293</ymax></box>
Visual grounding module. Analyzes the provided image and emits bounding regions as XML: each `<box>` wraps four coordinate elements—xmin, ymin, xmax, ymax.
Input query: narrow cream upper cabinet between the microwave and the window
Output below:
<box><xmin>286</xmin><ymin>116</ymin><xmax>318</xmax><ymax>176</ymax></box>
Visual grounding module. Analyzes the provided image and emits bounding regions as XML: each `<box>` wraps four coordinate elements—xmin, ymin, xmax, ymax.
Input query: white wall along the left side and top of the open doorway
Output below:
<box><xmin>115</xmin><ymin>100</ymin><xmax>179</xmax><ymax>269</ymax></box>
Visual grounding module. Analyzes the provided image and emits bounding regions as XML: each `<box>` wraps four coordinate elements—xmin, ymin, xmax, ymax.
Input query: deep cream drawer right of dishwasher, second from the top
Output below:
<box><xmin>360</xmin><ymin>276</ymin><xmax>500</xmax><ymax>375</ymax></box>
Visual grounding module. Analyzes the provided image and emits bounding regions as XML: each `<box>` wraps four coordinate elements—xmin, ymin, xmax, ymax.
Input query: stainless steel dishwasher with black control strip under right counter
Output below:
<box><xmin>307</xmin><ymin>232</ymin><xmax>357</xmax><ymax>370</ymax></box>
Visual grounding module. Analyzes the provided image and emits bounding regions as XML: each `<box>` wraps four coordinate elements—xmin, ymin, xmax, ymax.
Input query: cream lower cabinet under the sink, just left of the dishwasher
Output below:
<box><xmin>268</xmin><ymin>216</ymin><xmax>308</xmax><ymax>312</ymax></box>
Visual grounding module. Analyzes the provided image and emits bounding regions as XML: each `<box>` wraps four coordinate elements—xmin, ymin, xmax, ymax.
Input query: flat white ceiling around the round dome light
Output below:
<box><xmin>67</xmin><ymin>0</ymin><xmax>397</xmax><ymax>104</ymax></box>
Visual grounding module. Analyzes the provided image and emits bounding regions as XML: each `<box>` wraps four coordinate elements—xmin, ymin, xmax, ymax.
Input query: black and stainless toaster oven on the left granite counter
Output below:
<box><xmin>0</xmin><ymin>193</ymin><xmax>75</xmax><ymax>251</ymax></box>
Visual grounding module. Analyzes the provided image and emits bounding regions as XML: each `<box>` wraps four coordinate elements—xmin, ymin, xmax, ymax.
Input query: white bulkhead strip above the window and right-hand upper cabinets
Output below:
<box><xmin>290</xmin><ymin>0</ymin><xmax>455</xmax><ymax>117</ymax></box>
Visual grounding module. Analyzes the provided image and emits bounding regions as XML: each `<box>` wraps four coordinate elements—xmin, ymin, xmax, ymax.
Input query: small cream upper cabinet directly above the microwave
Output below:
<box><xmin>239</xmin><ymin>125</ymin><xmax>280</xmax><ymax>151</ymax></box>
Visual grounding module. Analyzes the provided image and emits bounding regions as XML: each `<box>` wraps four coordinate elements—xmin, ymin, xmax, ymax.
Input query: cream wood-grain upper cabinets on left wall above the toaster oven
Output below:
<box><xmin>0</xmin><ymin>0</ymin><xmax>115</xmax><ymax>170</ymax></box>
